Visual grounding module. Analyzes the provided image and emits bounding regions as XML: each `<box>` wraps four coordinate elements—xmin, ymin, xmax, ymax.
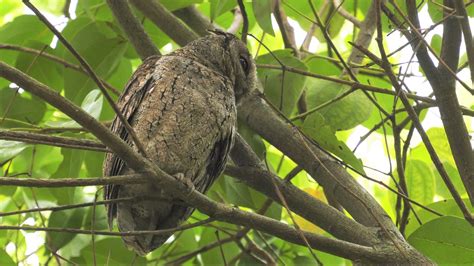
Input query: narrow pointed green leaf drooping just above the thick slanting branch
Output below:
<box><xmin>302</xmin><ymin>113</ymin><xmax>364</xmax><ymax>173</ymax></box>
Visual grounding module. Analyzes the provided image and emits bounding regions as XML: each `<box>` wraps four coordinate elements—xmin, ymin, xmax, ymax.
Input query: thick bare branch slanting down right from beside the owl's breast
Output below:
<box><xmin>238</xmin><ymin>90</ymin><xmax>394</xmax><ymax>228</ymax></box>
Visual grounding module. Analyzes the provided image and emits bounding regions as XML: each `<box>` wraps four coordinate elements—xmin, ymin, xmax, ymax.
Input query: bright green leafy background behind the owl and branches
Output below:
<box><xmin>0</xmin><ymin>0</ymin><xmax>474</xmax><ymax>265</ymax></box>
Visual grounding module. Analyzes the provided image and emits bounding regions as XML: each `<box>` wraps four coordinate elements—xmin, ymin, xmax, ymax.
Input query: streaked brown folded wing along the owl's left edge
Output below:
<box><xmin>103</xmin><ymin>56</ymin><xmax>160</xmax><ymax>226</ymax></box>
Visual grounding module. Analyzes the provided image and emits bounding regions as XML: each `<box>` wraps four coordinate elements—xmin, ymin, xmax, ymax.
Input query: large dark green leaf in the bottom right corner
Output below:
<box><xmin>408</xmin><ymin>216</ymin><xmax>474</xmax><ymax>264</ymax></box>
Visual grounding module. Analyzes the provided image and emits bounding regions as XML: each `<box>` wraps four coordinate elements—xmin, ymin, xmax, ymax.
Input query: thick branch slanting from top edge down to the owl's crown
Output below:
<box><xmin>131</xmin><ymin>0</ymin><xmax>199</xmax><ymax>46</ymax></box>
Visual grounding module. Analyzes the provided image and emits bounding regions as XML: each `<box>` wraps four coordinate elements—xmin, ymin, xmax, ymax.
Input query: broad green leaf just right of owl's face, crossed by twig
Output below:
<box><xmin>256</xmin><ymin>49</ymin><xmax>307</xmax><ymax>116</ymax></box>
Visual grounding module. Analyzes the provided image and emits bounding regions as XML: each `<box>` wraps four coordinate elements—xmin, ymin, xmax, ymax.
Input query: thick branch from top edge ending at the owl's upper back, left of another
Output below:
<box><xmin>107</xmin><ymin>0</ymin><xmax>160</xmax><ymax>60</ymax></box>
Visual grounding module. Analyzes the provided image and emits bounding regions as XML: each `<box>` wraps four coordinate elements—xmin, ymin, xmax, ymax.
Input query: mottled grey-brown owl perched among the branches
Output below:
<box><xmin>103</xmin><ymin>32</ymin><xmax>257</xmax><ymax>255</ymax></box>
